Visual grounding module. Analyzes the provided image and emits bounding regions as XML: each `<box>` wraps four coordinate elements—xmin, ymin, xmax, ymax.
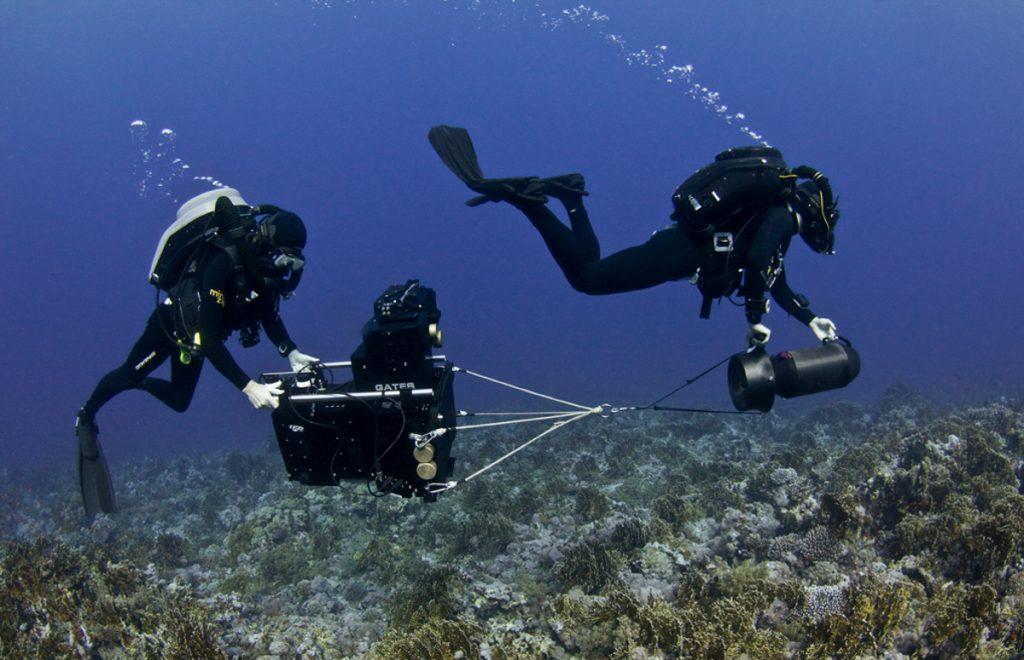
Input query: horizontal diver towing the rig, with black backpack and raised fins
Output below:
<box><xmin>428</xmin><ymin>126</ymin><xmax>839</xmax><ymax>346</ymax></box>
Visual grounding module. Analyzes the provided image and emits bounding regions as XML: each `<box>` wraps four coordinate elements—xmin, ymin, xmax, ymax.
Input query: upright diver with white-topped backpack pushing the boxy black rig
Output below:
<box><xmin>75</xmin><ymin>188</ymin><xmax>318</xmax><ymax>521</ymax></box>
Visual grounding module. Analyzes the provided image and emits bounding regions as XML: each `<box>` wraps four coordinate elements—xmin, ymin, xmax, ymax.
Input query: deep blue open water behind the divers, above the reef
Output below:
<box><xmin>0</xmin><ymin>0</ymin><xmax>1024</xmax><ymax>465</ymax></box>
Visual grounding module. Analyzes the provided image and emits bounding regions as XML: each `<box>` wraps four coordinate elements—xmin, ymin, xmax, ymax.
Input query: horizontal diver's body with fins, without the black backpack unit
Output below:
<box><xmin>429</xmin><ymin>127</ymin><xmax>839</xmax><ymax>345</ymax></box>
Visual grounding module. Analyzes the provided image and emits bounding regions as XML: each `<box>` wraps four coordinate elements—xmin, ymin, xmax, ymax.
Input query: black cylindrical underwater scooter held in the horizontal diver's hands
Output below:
<box><xmin>729</xmin><ymin>339</ymin><xmax>860</xmax><ymax>412</ymax></box>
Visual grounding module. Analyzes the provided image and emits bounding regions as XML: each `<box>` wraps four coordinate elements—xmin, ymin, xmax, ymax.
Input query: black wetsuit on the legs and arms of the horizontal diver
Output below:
<box><xmin>516</xmin><ymin>197</ymin><xmax>815</xmax><ymax>324</ymax></box>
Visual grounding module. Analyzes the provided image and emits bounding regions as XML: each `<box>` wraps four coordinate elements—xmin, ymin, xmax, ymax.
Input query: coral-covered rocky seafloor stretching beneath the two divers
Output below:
<box><xmin>0</xmin><ymin>387</ymin><xmax>1024</xmax><ymax>658</ymax></box>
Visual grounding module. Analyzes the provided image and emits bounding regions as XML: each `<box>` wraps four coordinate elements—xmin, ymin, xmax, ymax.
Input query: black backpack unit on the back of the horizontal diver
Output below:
<box><xmin>672</xmin><ymin>146</ymin><xmax>794</xmax><ymax>235</ymax></box>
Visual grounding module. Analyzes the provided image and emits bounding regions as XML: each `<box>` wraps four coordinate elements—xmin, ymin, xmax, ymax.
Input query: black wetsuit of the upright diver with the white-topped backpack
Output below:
<box><xmin>82</xmin><ymin>250</ymin><xmax>296</xmax><ymax>419</ymax></box>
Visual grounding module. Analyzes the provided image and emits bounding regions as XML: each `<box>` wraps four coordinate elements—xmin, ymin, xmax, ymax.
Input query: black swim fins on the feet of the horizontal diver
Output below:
<box><xmin>427</xmin><ymin>126</ymin><xmax>548</xmax><ymax>207</ymax></box>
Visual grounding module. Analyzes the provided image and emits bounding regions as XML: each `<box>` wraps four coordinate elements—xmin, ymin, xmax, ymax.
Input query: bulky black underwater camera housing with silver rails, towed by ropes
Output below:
<box><xmin>262</xmin><ymin>279</ymin><xmax>456</xmax><ymax>501</ymax></box>
